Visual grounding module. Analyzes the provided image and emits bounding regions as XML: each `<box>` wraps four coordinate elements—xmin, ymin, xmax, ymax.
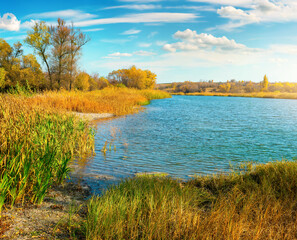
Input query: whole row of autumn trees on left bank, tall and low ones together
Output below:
<box><xmin>0</xmin><ymin>18</ymin><xmax>157</xmax><ymax>92</ymax></box>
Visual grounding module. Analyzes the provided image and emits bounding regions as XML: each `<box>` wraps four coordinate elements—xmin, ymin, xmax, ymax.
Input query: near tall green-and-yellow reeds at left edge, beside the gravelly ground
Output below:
<box><xmin>0</xmin><ymin>95</ymin><xmax>94</xmax><ymax>211</ymax></box>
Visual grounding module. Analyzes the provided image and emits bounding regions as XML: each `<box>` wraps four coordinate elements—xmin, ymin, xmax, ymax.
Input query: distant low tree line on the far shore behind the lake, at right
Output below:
<box><xmin>157</xmin><ymin>75</ymin><xmax>297</xmax><ymax>93</ymax></box>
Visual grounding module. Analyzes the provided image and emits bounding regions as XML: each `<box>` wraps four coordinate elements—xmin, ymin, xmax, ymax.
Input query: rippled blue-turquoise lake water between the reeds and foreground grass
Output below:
<box><xmin>77</xmin><ymin>96</ymin><xmax>297</xmax><ymax>191</ymax></box>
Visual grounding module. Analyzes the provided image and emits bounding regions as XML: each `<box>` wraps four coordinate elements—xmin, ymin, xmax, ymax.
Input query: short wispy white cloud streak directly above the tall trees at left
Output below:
<box><xmin>25</xmin><ymin>9</ymin><xmax>97</xmax><ymax>20</ymax></box>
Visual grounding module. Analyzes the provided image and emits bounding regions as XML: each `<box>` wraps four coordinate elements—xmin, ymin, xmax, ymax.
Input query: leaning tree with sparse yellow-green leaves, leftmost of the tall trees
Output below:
<box><xmin>25</xmin><ymin>21</ymin><xmax>53</xmax><ymax>89</ymax></box>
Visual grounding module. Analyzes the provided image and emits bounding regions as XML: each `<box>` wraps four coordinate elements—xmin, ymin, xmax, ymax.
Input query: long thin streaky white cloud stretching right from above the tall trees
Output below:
<box><xmin>74</xmin><ymin>12</ymin><xmax>198</xmax><ymax>27</ymax></box>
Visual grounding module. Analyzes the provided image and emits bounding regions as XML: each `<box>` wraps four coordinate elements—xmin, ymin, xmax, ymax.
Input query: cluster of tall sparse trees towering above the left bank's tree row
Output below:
<box><xmin>25</xmin><ymin>18</ymin><xmax>89</xmax><ymax>90</ymax></box>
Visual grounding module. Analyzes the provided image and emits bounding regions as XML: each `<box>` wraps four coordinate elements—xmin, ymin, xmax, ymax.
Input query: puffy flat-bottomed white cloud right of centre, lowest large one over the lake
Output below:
<box><xmin>163</xmin><ymin>29</ymin><xmax>251</xmax><ymax>52</ymax></box>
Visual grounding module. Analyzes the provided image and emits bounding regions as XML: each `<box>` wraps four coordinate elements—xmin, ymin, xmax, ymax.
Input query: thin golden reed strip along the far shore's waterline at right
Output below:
<box><xmin>171</xmin><ymin>92</ymin><xmax>297</xmax><ymax>99</ymax></box>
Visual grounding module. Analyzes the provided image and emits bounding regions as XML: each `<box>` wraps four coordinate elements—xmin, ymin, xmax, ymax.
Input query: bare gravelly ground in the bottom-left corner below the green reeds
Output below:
<box><xmin>0</xmin><ymin>183</ymin><xmax>90</xmax><ymax>240</ymax></box>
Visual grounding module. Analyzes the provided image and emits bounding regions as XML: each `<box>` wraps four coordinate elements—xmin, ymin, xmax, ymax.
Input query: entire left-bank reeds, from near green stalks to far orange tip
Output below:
<box><xmin>0</xmin><ymin>87</ymin><xmax>170</xmax><ymax>212</ymax></box>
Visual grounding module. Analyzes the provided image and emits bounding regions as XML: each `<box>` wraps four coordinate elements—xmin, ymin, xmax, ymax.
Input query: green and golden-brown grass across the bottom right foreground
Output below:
<box><xmin>84</xmin><ymin>161</ymin><xmax>297</xmax><ymax>240</ymax></box>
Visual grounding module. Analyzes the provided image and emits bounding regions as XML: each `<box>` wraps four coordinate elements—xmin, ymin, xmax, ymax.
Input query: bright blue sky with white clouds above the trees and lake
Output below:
<box><xmin>0</xmin><ymin>0</ymin><xmax>297</xmax><ymax>83</ymax></box>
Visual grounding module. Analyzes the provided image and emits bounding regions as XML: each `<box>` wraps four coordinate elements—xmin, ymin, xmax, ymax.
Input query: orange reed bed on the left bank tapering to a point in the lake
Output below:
<box><xmin>24</xmin><ymin>87</ymin><xmax>170</xmax><ymax>115</ymax></box>
